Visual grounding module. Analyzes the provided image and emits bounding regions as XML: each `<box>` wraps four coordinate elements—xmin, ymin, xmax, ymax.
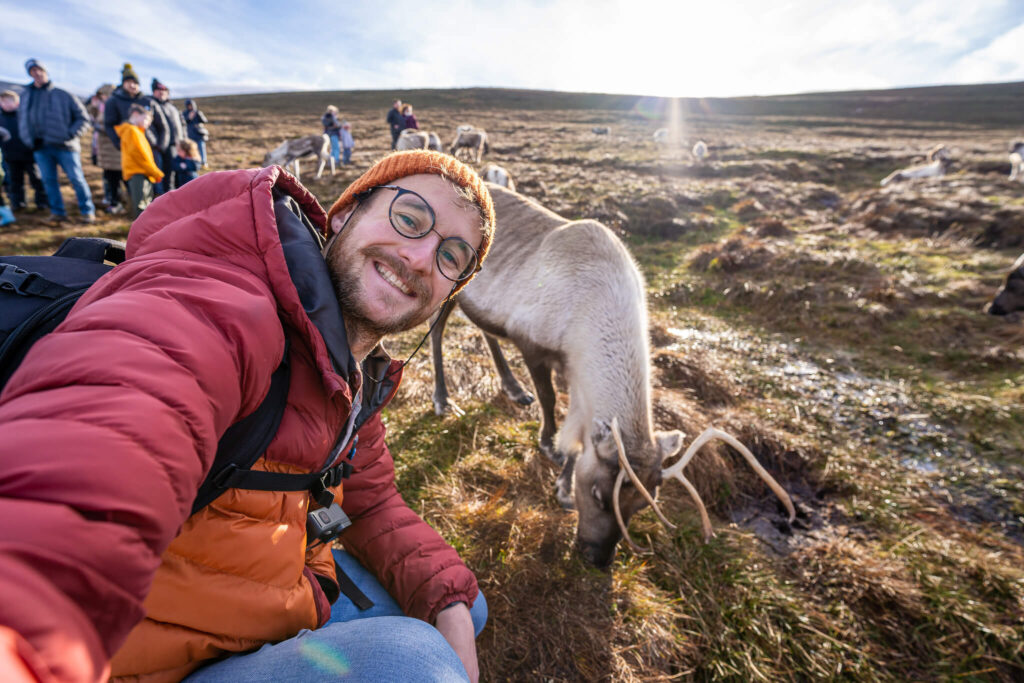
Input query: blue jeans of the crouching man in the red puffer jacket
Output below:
<box><xmin>184</xmin><ymin>550</ymin><xmax>487</xmax><ymax>683</ymax></box>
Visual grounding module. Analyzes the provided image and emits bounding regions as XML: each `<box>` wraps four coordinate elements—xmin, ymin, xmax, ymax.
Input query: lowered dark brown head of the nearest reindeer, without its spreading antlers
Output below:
<box><xmin>574</xmin><ymin>419</ymin><xmax>683</xmax><ymax>567</ymax></box>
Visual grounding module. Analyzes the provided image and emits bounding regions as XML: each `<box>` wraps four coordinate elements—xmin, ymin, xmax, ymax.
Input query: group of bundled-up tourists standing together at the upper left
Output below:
<box><xmin>0</xmin><ymin>59</ymin><xmax>210</xmax><ymax>225</ymax></box>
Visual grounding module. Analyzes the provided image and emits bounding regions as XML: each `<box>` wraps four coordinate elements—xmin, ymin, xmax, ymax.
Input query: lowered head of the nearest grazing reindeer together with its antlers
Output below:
<box><xmin>575</xmin><ymin>418</ymin><xmax>797</xmax><ymax>567</ymax></box>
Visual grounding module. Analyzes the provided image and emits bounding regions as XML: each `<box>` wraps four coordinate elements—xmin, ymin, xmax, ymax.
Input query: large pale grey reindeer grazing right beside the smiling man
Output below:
<box><xmin>430</xmin><ymin>185</ymin><xmax>794</xmax><ymax>566</ymax></box>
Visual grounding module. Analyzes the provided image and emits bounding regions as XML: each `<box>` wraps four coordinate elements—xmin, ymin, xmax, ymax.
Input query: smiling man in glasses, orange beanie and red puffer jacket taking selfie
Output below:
<box><xmin>0</xmin><ymin>151</ymin><xmax>495</xmax><ymax>683</ymax></box>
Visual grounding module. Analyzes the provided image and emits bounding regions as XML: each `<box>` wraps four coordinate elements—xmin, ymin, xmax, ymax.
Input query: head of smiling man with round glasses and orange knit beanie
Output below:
<box><xmin>324</xmin><ymin>150</ymin><xmax>495</xmax><ymax>358</ymax></box>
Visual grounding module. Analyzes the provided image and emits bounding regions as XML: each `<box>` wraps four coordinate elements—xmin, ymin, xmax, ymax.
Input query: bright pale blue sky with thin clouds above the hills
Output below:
<box><xmin>0</xmin><ymin>0</ymin><xmax>1024</xmax><ymax>97</ymax></box>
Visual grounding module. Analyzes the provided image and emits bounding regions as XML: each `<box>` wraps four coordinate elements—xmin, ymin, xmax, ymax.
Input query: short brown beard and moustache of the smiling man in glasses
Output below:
<box><xmin>326</xmin><ymin>229</ymin><xmax>432</xmax><ymax>343</ymax></box>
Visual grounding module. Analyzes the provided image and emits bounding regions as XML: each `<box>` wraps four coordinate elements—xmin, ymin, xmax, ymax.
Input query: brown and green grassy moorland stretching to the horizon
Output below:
<box><xmin>0</xmin><ymin>85</ymin><xmax>1024</xmax><ymax>681</ymax></box>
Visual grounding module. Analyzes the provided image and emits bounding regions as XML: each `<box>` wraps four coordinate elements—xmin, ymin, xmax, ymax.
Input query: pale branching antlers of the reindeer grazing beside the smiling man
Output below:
<box><xmin>611</xmin><ymin>418</ymin><xmax>797</xmax><ymax>553</ymax></box>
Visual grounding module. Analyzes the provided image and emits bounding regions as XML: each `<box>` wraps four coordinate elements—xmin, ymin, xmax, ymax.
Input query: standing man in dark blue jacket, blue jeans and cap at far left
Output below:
<box><xmin>17</xmin><ymin>59</ymin><xmax>96</xmax><ymax>223</ymax></box>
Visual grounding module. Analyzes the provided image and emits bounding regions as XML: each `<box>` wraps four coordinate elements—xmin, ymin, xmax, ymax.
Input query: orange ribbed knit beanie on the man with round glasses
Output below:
<box><xmin>327</xmin><ymin>150</ymin><xmax>495</xmax><ymax>282</ymax></box>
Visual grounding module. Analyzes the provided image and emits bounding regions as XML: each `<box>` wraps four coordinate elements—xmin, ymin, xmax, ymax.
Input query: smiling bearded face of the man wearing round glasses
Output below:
<box><xmin>326</xmin><ymin>174</ymin><xmax>482</xmax><ymax>339</ymax></box>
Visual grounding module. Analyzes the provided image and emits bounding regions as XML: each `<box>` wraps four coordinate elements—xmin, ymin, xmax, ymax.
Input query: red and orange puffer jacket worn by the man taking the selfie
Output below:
<box><xmin>0</xmin><ymin>168</ymin><xmax>477</xmax><ymax>681</ymax></box>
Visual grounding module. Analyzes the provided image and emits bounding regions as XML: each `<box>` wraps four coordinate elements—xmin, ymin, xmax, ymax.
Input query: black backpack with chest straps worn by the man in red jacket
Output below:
<box><xmin>0</xmin><ymin>238</ymin><xmax>354</xmax><ymax>516</ymax></box>
